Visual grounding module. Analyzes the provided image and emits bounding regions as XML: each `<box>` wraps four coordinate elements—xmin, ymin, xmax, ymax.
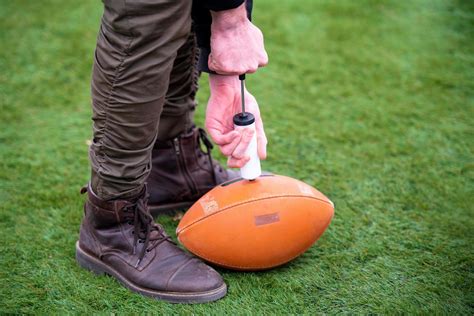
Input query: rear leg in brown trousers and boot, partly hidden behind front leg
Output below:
<box><xmin>147</xmin><ymin>33</ymin><xmax>238</xmax><ymax>214</ymax></box>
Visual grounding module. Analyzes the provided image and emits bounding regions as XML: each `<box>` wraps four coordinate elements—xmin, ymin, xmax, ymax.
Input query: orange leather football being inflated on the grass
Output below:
<box><xmin>176</xmin><ymin>175</ymin><xmax>334</xmax><ymax>270</ymax></box>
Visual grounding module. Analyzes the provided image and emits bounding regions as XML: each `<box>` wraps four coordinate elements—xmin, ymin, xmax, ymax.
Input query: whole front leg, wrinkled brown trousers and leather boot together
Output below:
<box><xmin>76</xmin><ymin>0</ymin><xmax>226</xmax><ymax>302</ymax></box>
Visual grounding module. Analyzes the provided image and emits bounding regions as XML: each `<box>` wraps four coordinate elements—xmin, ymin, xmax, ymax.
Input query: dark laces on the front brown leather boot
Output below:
<box><xmin>123</xmin><ymin>194</ymin><xmax>176</xmax><ymax>268</ymax></box>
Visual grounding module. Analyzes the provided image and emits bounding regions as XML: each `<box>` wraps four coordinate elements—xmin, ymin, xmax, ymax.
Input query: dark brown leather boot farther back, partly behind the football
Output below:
<box><xmin>147</xmin><ymin>127</ymin><xmax>240</xmax><ymax>215</ymax></box>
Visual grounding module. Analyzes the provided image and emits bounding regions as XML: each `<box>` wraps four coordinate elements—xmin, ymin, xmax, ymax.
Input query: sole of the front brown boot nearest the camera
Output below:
<box><xmin>76</xmin><ymin>242</ymin><xmax>227</xmax><ymax>303</ymax></box>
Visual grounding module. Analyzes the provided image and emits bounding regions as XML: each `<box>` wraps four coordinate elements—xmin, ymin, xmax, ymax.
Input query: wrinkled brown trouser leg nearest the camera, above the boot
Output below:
<box><xmin>90</xmin><ymin>0</ymin><xmax>190</xmax><ymax>199</ymax></box>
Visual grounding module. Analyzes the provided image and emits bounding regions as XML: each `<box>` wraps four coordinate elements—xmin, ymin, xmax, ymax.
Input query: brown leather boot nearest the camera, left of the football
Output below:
<box><xmin>76</xmin><ymin>185</ymin><xmax>227</xmax><ymax>303</ymax></box>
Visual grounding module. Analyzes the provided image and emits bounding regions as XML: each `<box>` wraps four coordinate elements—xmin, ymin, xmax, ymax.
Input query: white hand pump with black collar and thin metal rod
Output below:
<box><xmin>233</xmin><ymin>74</ymin><xmax>262</xmax><ymax>180</ymax></box>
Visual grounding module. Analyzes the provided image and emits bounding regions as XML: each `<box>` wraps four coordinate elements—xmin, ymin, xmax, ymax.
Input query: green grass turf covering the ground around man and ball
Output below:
<box><xmin>0</xmin><ymin>0</ymin><xmax>474</xmax><ymax>314</ymax></box>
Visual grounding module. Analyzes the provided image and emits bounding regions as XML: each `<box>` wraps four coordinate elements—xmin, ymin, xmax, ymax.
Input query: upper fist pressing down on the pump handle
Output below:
<box><xmin>208</xmin><ymin>3</ymin><xmax>268</xmax><ymax>75</ymax></box>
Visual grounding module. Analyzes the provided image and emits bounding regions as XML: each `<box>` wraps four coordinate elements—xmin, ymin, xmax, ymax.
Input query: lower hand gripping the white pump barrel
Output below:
<box><xmin>206</xmin><ymin>75</ymin><xmax>267</xmax><ymax>168</ymax></box>
